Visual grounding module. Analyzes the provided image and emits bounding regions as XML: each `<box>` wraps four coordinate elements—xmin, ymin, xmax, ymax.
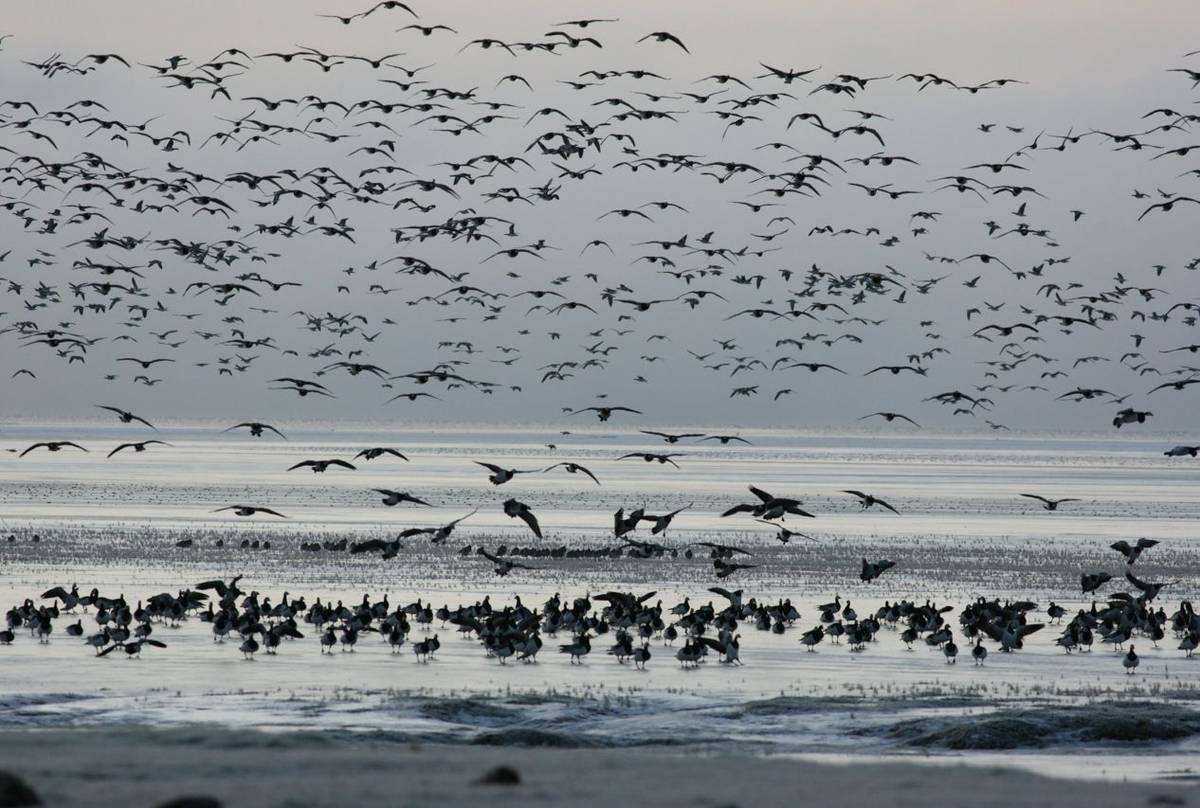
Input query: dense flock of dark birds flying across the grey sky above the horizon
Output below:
<box><xmin>0</xmin><ymin>7</ymin><xmax>1200</xmax><ymax>430</ymax></box>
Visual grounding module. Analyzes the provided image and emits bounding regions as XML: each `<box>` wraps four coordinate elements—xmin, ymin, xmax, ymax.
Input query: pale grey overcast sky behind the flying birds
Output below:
<box><xmin>0</xmin><ymin>1</ymin><xmax>1200</xmax><ymax>430</ymax></box>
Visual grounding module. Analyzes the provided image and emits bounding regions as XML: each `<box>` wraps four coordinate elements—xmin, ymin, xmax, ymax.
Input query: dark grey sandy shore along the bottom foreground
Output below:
<box><xmin>0</xmin><ymin>728</ymin><xmax>1195</xmax><ymax>808</ymax></box>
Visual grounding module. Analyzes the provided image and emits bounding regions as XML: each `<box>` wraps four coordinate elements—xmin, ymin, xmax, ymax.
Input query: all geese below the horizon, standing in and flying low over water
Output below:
<box><xmin>7</xmin><ymin>405</ymin><xmax>1200</xmax><ymax>672</ymax></box>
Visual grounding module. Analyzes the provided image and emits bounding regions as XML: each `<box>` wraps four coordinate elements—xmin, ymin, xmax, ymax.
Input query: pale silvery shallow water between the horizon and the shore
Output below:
<box><xmin>0</xmin><ymin>424</ymin><xmax>1200</xmax><ymax>778</ymax></box>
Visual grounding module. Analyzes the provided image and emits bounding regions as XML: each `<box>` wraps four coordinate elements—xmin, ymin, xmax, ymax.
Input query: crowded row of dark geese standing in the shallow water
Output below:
<box><xmin>0</xmin><ymin>571</ymin><xmax>1200</xmax><ymax>674</ymax></box>
